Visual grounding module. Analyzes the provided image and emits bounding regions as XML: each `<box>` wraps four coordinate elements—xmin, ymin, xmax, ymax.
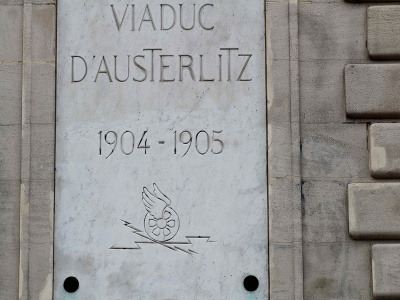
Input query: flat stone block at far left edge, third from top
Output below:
<box><xmin>0</xmin><ymin>125</ymin><xmax>21</xmax><ymax>180</ymax></box>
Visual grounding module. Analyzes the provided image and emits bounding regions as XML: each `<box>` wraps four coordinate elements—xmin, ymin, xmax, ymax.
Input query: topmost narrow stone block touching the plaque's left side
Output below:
<box><xmin>32</xmin><ymin>5</ymin><xmax>56</xmax><ymax>61</ymax></box>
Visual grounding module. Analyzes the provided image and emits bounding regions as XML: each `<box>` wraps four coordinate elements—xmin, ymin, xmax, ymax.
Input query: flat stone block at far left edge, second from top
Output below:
<box><xmin>0</xmin><ymin>63</ymin><xmax>22</xmax><ymax>125</ymax></box>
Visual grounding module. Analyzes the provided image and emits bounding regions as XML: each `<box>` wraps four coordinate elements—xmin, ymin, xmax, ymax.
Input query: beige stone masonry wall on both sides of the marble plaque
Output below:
<box><xmin>0</xmin><ymin>0</ymin><xmax>400</xmax><ymax>300</ymax></box>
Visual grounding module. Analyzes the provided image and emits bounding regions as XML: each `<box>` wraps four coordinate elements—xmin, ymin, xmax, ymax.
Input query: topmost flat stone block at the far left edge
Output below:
<box><xmin>0</xmin><ymin>5</ymin><xmax>23</xmax><ymax>61</ymax></box>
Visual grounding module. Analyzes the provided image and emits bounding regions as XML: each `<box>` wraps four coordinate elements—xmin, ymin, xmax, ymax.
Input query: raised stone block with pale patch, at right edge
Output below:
<box><xmin>369</xmin><ymin>123</ymin><xmax>400</xmax><ymax>178</ymax></box>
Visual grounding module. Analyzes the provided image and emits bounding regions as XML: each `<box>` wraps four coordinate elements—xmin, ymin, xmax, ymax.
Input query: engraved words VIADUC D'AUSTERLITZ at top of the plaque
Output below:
<box><xmin>71</xmin><ymin>4</ymin><xmax>252</xmax><ymax>83</ymax></box>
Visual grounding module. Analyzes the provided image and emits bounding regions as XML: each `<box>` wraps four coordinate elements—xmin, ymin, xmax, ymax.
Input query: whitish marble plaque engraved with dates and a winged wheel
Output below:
<box><xmin>54</xmin><ymin>0</ymin><xmax>268</xmax><ymax>300</ymax></box>
